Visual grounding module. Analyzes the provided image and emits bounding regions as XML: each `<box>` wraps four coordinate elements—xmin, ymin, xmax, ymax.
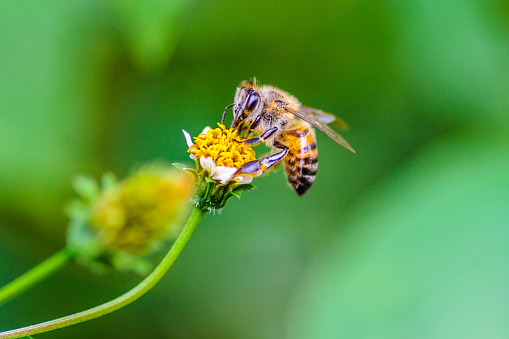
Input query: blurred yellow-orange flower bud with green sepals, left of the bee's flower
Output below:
<box><xmin>68</xmin><ymin>164</ymin><xmax>194</xmax><ymax>273</ymax></box>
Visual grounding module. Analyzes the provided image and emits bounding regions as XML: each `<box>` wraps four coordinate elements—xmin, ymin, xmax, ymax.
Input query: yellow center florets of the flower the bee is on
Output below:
<box><xmin>187</xmin><ymin>123</ymin><xmax>256</xmax><ymax>168</ymax></box>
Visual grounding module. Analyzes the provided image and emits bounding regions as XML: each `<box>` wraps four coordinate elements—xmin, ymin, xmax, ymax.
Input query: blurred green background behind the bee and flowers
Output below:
<box><xmin>0</xmin><ymin>0</ymin><xmax>509</xmax><ymax>338</ymax></box>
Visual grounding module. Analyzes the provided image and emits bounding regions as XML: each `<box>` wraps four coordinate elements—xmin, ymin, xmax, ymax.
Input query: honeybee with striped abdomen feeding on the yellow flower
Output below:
<box><xmin>221</xmin><ymin>78</ymin><xmax>355</xmax><ymax>196</ymax></box>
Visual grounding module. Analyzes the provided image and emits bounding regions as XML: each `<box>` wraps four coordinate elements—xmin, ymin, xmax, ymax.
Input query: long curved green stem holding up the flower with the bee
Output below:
<box><xmin>0</xmin><ymin>208</ymin><xmax>205</xmax><ymax>338</ymax></box>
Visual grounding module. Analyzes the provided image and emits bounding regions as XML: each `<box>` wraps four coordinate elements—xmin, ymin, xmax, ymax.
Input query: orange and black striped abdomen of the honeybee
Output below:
<box><xmin>284</xmin><ymin>122</ymin><xmax>318</xmax><ymax>196</ymax></box>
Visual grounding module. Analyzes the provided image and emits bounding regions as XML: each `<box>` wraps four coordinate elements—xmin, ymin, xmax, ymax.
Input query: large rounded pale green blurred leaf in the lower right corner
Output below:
<box><xmin>289</xmin><ymin>136</ymin><xmax>509</xmax><ymax>338</ymax></box>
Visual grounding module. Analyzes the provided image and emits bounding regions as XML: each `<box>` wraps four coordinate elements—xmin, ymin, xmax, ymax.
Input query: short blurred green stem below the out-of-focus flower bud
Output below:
<box><xmin>0</xmin><ymin>248</ymin><xmax>73</xmax><ymax>306</ymax></box>
